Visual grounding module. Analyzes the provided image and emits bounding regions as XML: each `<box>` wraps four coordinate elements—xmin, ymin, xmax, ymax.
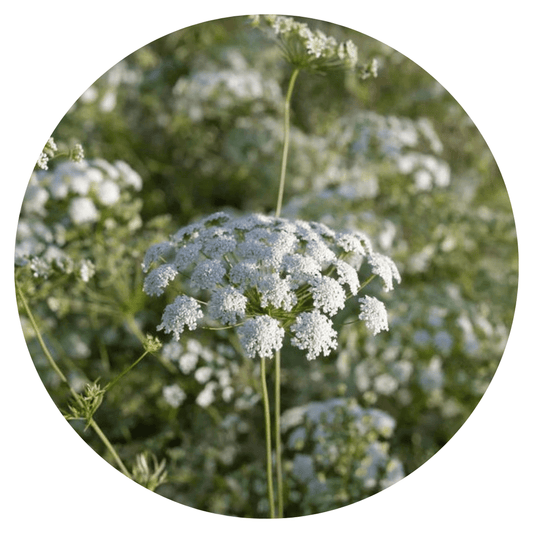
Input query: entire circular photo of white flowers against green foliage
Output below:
<box><xmin>15</xmin><ymin>16</ymin><xmax>518</xmax><ymax>518</ymax></box>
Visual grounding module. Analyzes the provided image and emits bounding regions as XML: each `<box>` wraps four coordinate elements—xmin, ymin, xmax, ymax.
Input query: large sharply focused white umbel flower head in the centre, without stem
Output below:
<box><xmin>143</xmin><ymin>212</ymin><xmax>400</xmax><ymax>360</ymax></box>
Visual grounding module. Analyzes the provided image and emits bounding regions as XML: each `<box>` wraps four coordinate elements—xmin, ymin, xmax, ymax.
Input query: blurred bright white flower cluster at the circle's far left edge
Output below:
<box><xmin>15</xmin><ymin>155</ymin><xmax>142</xmax><ymax>281</ymax></box>
